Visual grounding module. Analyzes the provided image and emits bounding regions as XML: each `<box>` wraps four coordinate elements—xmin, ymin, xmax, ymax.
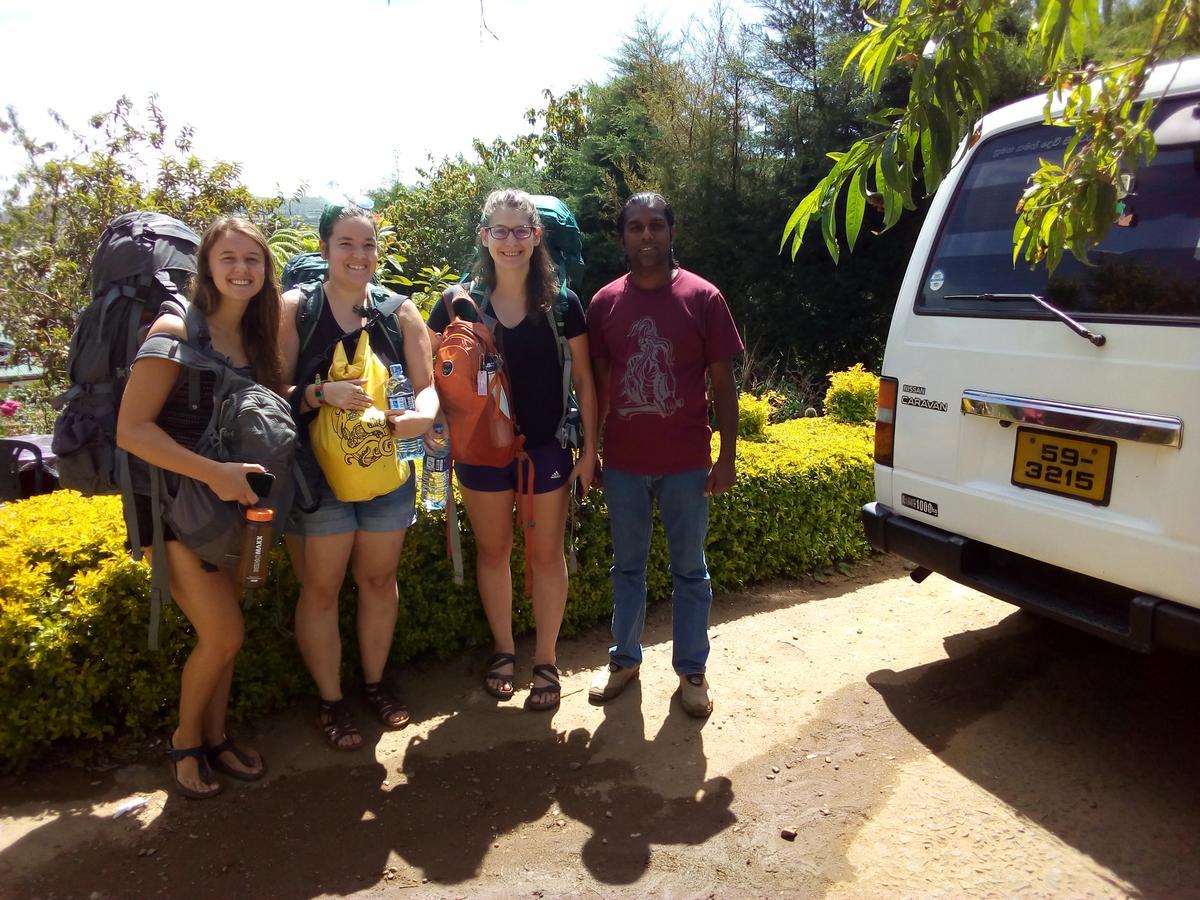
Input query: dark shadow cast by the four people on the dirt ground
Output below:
<box><xmin>0</xmin><ymin>558</ymin><xmax>904</xmax><ymax>898</ymax></box>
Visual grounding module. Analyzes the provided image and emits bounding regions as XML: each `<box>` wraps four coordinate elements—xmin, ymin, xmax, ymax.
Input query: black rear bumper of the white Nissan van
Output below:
<box><xmin>862</xmin><ymin>502</ymin><xmax>1200</xmax><ymax>654</ymax></box>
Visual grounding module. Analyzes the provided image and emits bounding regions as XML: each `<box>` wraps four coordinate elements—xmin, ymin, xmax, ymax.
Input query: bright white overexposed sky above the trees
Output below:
<box><xmin>0</xmin><ymin>0</ymin><xmax>758</xmax><ymax>198</ymax></box>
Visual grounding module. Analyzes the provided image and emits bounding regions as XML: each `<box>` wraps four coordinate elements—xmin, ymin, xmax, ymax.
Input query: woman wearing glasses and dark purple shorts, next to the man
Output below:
<box><xmin>428</xmin><ymin>190</ymin><xmax>598</xmax><ymax>712</ymax></box>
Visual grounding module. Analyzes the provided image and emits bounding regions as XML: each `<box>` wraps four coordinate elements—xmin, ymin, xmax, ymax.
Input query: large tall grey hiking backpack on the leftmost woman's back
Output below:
<box><xmin>53</xmin><ymin>212</ymin><xmax>200</xmax><ymax>497</ymax></box>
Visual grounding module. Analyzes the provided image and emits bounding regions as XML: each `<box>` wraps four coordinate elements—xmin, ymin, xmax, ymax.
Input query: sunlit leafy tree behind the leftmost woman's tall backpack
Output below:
<box><xmin>0</xmin><ymin>97</ymin><xmax>282</xmax><ymax>380</ymax></box>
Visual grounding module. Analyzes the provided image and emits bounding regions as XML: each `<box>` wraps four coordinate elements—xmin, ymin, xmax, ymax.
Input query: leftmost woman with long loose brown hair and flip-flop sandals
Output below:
<box><xmin>116</xmin><ymin>218</ymin><xmax>283</xmax><ymax>799</ymax></box>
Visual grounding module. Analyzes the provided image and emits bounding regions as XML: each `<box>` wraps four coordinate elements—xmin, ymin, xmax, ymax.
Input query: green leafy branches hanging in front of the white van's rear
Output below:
<box><xmin>780</xmin><ymin>0</ymin><xmax>1200</xmax><ymax>270</ymax></box>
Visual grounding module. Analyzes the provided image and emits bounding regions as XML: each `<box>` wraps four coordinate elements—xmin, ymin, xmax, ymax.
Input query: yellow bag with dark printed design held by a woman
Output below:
<box><xmin>308</xmin><ymin>331</ymin><xmax>408</xmax><ymax>503</ymax></box>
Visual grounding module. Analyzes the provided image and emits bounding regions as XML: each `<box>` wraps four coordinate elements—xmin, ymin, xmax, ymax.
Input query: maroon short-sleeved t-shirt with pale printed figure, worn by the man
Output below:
<box><xmin>588</xmin><ymin>269</ymin><xmax>743</xmax><ymax>475</ymax></box>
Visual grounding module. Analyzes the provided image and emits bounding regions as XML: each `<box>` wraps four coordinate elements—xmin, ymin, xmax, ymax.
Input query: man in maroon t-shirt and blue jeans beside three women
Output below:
<box><xmin>588</xmin><ymin>193</ymin><xmax>743</xmax><ymax>716</ymax></box>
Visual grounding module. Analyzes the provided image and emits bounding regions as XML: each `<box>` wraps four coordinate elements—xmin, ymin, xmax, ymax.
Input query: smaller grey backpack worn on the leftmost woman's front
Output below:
<box><xmin>132</xmin><ymin>306</ymin><xmax>296</xmax><ymax>649</ymax></box>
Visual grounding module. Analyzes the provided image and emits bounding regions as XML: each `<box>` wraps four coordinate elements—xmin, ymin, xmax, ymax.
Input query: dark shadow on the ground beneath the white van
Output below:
<box><xmin>868</xmin><ymin>613</ymin><xmax>1200</xmax><ymax>896</ymax></box>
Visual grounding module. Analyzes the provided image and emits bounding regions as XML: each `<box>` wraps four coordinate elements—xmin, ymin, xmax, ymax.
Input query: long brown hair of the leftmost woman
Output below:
<box><xmin>191</xmin><ymin>216</ymin><xmax>283</xmax><ymax>392</ymax></box>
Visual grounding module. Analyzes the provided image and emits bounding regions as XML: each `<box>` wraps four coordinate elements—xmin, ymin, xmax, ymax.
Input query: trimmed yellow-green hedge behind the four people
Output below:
<box><xmin>0</xmin><ymin>419</ymin><xmax>871</xmax><ymax>770</ymax></box>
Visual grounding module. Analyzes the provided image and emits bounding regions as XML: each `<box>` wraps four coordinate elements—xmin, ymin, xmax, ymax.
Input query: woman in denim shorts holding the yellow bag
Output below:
<box><xmin>280</xmin><ymin>206</ymin><xmax>438</xmax><ymax>750</ymax></box>
